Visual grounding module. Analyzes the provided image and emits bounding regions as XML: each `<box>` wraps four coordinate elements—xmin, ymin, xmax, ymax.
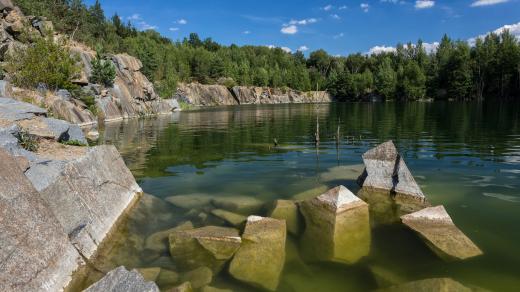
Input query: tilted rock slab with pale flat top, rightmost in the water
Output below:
<box><xmin>401</xmin><ymin>206</ymin><xmax>482</xmax><ymax>260</ymax></box>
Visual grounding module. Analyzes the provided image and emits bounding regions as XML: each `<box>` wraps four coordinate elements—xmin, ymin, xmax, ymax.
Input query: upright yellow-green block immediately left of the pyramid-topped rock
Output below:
<box><xmin>229</xmin><ymin>216</ymin><xmax>287</xmax><ymax>291</ymax></box>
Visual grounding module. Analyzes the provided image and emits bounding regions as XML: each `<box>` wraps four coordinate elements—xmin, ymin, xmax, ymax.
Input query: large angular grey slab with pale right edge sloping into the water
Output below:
<box><xmin>35</xmin><ymin>146</ymin><xmax>142</xmax><ymax>258</ymax></box>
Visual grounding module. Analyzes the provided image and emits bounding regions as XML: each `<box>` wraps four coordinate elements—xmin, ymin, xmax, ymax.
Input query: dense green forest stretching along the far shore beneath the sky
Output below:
<box><xmin>14</xmin><ymin>0</ymin><xmax>520</xmax><ymax>100</ymax></box>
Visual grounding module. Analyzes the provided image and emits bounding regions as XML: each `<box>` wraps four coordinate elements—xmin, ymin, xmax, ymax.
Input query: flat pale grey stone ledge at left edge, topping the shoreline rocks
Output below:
<box><xmin>0</xmin><ymin>97</ymin><xmax>47</xmax><ymax>121</ymax></box>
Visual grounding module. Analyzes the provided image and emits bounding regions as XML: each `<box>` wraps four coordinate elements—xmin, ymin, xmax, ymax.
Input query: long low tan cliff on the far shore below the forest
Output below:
<box><xmin>175</xmin><ymin>83</ymin><xmax>333</xmax><ymax>106</ymax></box>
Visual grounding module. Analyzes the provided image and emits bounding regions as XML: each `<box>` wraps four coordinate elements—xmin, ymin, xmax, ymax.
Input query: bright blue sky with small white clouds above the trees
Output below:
<box><xmin>85</xmin><ymin>0</ymin><xmax>520</xmax><ymax>55</ymax></box>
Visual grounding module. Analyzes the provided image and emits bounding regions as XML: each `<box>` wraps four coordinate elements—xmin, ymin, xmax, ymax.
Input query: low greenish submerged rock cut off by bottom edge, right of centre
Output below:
<box><xmin>379</xmin><ymin>278</ymin><xmax>473</xmax><ymax>292</ymax></box>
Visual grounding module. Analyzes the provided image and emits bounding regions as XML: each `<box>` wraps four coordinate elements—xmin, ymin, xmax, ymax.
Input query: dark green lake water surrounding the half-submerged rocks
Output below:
<box><xmin>82</xmin><ymin>102</ymin><xmax>520</xmax><ymax>291</ymax></box>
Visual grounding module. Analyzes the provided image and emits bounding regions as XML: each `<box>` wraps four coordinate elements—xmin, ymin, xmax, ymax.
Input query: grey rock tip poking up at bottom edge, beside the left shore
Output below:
<box><xmin>85</xmin><ymin>267</ymin><xmax>159</xmax><ymax>292</ymax></box>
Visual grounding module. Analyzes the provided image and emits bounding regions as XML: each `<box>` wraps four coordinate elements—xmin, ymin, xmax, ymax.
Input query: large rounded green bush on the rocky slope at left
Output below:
<box><xmin>5</xmin><ymin>38</ymin><xmax>80</xmax><ymax>89</ymax></box>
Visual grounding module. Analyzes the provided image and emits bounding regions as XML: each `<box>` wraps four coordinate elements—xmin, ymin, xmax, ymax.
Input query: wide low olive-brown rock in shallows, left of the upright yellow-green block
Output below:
<box><xmin>169</xmin><ymin>226</ymin><xmax>241</xmax><ymax>272</ymax></box>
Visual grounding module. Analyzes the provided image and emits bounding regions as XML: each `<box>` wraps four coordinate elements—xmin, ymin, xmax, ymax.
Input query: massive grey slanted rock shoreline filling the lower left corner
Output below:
<box><xmin>0</xmin><ymin>98</ymin><xmax>142</xmax><ymax>291</ymax></box>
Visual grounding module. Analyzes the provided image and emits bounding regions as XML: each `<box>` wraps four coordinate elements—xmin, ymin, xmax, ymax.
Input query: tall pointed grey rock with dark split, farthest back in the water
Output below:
<box><xmin>358</xmin><ymin>141</ymin><xmax>429</xmax><ymax>211</ymax></box>
